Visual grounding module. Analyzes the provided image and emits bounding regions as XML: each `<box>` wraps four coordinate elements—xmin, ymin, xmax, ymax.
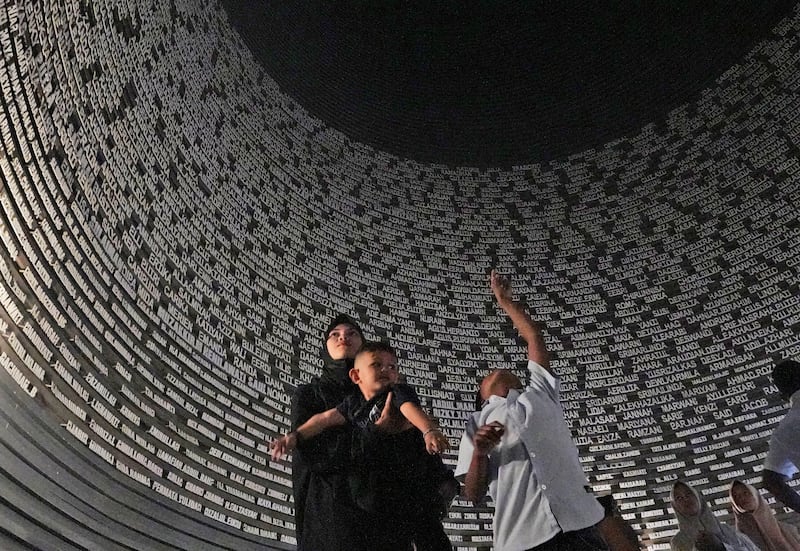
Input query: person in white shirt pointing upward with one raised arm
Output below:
<box><xmin>456</xmin><ymin>271</ymin><xmax>607</xmax><ymax>551</ymax></box>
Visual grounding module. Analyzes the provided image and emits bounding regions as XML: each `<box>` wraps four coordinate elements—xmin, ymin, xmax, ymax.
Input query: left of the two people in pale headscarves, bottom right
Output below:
<box><xmin>670</xmin><ymin>481</ymin><xmax>761</xmax><ymax>551</ymax></box>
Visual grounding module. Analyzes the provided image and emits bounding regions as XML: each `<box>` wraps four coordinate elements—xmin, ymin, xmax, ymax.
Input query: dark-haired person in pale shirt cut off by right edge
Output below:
<box><xmin>762</xmin><ymin>360</ymin><xmax>800</xmax><ymax>513</ymax></box>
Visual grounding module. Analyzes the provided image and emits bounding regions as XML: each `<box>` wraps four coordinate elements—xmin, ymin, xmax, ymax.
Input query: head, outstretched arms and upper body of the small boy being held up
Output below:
<box><xmin>270</xmin><ymin>342</ymin><xmax>450</xmax><ymax>460</ymax></box>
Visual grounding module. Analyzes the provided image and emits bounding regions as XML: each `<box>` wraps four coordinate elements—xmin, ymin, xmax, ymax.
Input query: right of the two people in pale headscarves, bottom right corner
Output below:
<box><xmin>730</xmin><ymin>480</ymin><xmax>800</xmax><ymax>551</ymax></box>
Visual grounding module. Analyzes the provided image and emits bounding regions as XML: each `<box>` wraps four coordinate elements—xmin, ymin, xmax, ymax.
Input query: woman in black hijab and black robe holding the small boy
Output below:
<box><xmin>291</xmin><ymin>314</ymin><xmax>366</xmax><ymax>551</ymax></box>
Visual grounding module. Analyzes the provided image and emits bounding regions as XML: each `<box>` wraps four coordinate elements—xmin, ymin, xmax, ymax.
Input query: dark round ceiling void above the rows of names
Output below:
<box><xmin>222</xmin><ymin>0</ymin><xmax>795</xmax><ymax>167</ymax></box>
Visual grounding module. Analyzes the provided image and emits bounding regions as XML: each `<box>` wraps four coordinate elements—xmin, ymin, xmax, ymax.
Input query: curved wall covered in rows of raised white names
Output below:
<box><xmin>0</xmin><ymin>0</ymin><xmax>800</xmax><ymax>550</ymax></box>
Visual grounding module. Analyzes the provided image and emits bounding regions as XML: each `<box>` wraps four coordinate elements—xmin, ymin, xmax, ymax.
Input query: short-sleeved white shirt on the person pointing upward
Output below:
<box><xmin>456</xmin><ymin>360</ymin><xmax>603</xmax><ymax>551</ymax></box>
